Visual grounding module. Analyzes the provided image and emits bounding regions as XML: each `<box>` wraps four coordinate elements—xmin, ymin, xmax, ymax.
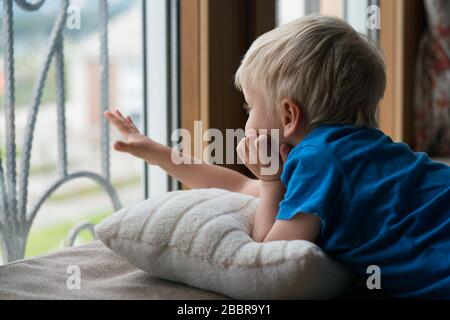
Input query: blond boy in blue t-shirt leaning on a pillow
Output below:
<box><xmin>106</xmin><ymin>16</ymin><xmax>450</xmax><ymax>299</ymax></box>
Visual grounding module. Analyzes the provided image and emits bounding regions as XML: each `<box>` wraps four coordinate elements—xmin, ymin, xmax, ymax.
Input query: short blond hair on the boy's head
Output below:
<box><xmin>235</xmin><ymin>15</ymin><xmax>386</xmax><ymax>128</ymax></box>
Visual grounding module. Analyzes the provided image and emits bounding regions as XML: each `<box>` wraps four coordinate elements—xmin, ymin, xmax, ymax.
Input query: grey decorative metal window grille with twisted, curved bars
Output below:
<box><xmin>0</xmin><ymin>0</ymin><xmax>121</xmax><ymax>263</ymax></box>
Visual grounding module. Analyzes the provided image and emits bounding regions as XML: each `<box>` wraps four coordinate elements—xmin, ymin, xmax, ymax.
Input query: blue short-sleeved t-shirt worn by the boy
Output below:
<box><xmin>277</xmin><ymin>125</ymin><xmax>450</xmax><ymax>299</ymax></box>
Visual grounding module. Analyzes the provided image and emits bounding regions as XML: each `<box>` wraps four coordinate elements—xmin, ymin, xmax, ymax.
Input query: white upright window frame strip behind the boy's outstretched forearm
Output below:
<box><xmin>144</xmin><ymin>0</ymin><xmax>180</xmax><ymax>196</ymax></box>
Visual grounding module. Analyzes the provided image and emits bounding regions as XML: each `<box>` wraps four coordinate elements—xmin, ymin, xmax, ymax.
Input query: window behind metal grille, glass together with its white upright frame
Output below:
<box><xmin>0</xmin><ymin>0</ymin><xmax>178</xmax><ymax>257</ymax></box>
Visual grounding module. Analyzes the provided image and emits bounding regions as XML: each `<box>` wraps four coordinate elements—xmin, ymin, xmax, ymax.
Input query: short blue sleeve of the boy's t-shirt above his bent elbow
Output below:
<box><xmin>277</xmin><ymin>146</ymin><xmax>344</xmax><ymax>233</ymax></box>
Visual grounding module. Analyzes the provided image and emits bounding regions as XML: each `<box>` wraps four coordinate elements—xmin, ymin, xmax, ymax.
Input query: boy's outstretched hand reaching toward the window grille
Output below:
<box><xmin>104</xmin><ymin>110</ymin><xmax>161</xmax><ymax>164</ymax></box>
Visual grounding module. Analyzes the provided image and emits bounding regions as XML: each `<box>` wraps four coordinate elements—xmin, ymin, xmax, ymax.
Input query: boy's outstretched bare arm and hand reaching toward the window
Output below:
<box><xmin>105</xmin><ymin>110</ymin><xmax>259</xmax><ymax>196</ymax></box>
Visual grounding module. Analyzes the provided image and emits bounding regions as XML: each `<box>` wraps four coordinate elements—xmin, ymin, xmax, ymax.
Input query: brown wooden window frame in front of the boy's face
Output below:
<box><xmin>180</xmin><ymin>0</ymin><xmax>275</xmax><ymax>182</ymax></box>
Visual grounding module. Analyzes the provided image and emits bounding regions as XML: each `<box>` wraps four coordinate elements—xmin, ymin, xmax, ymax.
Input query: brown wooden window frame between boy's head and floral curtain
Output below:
<box><xmin>379</xmin><ymin>0</ymin><xmax>424</xmax><ymax>147</ymax></box>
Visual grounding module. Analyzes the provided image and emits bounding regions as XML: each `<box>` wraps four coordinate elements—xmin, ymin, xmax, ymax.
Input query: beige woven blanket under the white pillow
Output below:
<box><xmin>0</xmin><ymin>241</ymin><xmax>227</xmax><ymax>300</ymax></box>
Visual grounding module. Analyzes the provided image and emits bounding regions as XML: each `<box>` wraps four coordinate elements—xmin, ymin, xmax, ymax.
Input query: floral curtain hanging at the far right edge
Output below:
<box><xmin>415</xmin><ymin>0</ymin><xmax>450</xmax><ymax>156</ymax></box>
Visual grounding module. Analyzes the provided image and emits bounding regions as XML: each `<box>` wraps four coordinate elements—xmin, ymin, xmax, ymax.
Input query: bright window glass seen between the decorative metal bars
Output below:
<box><xmin>0</xmin><ymin>0</ymin><xmax>144</xmax><ymax>257</ymax></box>
